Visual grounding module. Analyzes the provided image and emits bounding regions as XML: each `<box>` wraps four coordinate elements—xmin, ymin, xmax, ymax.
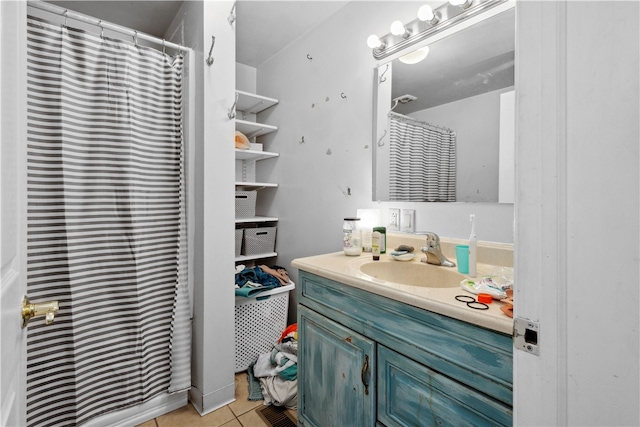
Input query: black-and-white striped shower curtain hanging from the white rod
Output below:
<box><xmin>27</xmin><ymin>17</ymin><xmax>190</xmax><ymax>426</ymax></box>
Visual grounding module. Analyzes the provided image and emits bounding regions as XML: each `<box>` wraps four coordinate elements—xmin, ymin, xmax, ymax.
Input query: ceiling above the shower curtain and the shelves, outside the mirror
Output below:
<box><xmin>47</xmin><ymin>0</ymin><xmax>348</xmax><ymax>68</ymax></box>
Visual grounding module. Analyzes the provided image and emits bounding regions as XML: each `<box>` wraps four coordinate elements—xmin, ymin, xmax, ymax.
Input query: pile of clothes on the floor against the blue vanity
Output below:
<box><xmin>249</xmin><ymin>323</ymin><xmax>298</xmax><ymax>409</ymax></box>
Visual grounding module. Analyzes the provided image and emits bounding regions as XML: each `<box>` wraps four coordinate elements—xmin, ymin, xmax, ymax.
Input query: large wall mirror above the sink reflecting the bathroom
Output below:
<box><xmin>373</xmin><ymin>2</ymin><xmax>515</xmax><ymax>203</ymax></box>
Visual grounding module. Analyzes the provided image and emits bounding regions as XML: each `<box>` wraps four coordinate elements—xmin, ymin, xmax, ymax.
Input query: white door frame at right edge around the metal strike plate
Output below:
<box><xmin>513</xmin><ymin>1</ymin><xmax>640</xmax><ymax>426</ymax></box>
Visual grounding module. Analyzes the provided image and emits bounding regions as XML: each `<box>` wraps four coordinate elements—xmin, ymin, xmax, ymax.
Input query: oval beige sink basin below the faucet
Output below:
<box><xmin>360</xmin><ymin>260</ymin><xmax>465</xmax><ymax>288</ymax></box>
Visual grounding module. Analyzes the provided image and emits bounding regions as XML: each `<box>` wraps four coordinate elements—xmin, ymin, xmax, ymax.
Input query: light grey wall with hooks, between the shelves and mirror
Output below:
<box><xmin>257</xmin><ymin>1</ymin><xmax>513</xmax><ymax>319</ymax></box>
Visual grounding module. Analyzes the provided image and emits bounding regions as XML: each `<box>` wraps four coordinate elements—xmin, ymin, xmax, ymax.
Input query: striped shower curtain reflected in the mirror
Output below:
<box><xmin>389</xmin><ymin>112</ymin><xmax>456</xmax><ymax>202</ymax></box>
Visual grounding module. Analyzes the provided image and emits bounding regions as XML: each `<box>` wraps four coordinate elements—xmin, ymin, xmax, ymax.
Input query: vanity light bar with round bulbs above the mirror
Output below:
<box><xmin>367</xmin><ymin>0</ymin><xmax>515</xmax><ymax>62</ymax></box>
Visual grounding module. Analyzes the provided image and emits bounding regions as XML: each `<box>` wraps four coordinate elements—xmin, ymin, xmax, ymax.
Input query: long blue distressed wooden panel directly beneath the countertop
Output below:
<box><xmin>298</xmin><ymin>271</ymin><xmax>513</xmax><ymax>406</ymax></box>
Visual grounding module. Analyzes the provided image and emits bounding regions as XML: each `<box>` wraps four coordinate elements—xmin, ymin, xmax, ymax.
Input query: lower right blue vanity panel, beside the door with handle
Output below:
<box><xmin>378</xmin><ymin>345</ymin><xmax>513</xmax><ymax>427</ymax></box>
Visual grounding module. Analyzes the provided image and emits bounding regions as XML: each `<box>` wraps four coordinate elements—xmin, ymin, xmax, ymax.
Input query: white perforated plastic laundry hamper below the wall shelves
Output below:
<box><xmin>235</xmin><ymin>282</ymin><xmax>296</xmax><ymax>373</ymax></box>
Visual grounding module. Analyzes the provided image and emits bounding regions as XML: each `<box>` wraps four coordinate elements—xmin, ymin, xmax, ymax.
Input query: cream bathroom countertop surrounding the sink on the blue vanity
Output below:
<box><xmin>292</xmin><ymin>251</ymin><xmax>513</xmax><ymax>335</ymax></box>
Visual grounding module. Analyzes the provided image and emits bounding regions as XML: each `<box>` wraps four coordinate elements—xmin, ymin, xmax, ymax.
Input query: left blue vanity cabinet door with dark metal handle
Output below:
<box><xmin>298</xmin><ymin>306</ymin><xmax>376</xmax><ymax>427</ymax></box>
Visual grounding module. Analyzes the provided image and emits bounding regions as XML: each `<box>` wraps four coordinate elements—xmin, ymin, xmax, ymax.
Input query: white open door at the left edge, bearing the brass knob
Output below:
<box><xmin>0</xmin><ymin>1</ymin><xmax>27</xmax><ymax>426</ymax></box>
